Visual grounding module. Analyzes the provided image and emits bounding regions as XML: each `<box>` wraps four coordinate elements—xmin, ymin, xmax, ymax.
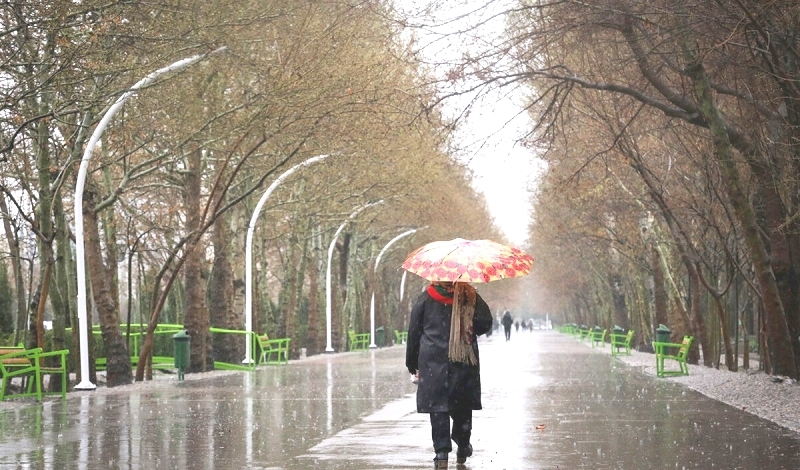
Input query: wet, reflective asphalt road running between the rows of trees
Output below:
<box><xmin>0</xmin><ymin>331</ymin><xmax>800</xmax><ymax>470</ymax></box>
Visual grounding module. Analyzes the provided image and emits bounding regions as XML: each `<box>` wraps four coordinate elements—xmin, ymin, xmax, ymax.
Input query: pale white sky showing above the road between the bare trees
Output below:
<box><xmin>397</xmin><ymin>0</ymin><xmax>542</xmax><ymax>246</ymax></box>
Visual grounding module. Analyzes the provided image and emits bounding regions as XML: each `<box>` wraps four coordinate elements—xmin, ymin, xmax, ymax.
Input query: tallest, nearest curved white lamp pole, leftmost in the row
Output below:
<box><xmin>74</xmin><ymin>47</ymin><xmax>225</xmax><ymax>390</ymax></box>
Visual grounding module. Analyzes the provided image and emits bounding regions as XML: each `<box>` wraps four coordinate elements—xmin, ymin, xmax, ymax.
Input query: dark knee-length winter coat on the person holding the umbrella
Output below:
<box><xmin>406</xmin><ymin>292</ymin><xmax>492</xmax><ymax>413</ymax></box>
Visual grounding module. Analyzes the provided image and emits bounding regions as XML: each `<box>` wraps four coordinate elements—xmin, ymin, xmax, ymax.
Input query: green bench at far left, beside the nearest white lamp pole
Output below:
<box><xmin>0</xmin><ymin>345</ymin><xmax>69</xmax><ymax>401</ymax></box>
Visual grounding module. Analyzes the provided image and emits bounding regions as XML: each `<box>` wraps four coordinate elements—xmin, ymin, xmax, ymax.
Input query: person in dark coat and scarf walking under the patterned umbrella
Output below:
<box><xmin>406</xmin><ymin>281</ymin><xmax>493</xmax><ymax>469</ymax></box>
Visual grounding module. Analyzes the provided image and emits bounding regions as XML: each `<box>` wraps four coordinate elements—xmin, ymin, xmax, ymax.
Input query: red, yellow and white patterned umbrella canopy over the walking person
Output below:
<box><xmin>402</xmin><ymin>238</ymin><xmax>533</xmax><ymax>282</ymax></box>
